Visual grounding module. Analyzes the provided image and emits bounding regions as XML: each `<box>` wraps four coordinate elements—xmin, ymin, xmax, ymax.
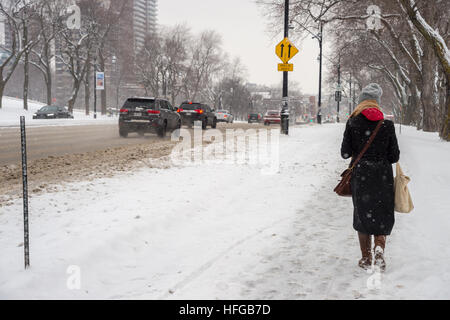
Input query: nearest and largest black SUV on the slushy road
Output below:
<box><xmin>119</xmin><ymin>98</ymin><xmax>181</xmax><ymax>138</ymax></box>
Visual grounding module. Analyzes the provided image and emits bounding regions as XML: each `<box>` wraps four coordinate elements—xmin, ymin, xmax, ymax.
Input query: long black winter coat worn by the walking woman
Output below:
<box><xmin>341</xmin><ymin>114</ymin><xmax>400</xmax><ymax>235</ymax></box>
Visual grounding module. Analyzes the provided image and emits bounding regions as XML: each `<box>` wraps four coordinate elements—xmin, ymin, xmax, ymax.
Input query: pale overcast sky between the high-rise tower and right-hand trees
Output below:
<box><xmin>158</xmin><ymin>0</ymin><xmax>330</xmax><ymax>95</ymax></box>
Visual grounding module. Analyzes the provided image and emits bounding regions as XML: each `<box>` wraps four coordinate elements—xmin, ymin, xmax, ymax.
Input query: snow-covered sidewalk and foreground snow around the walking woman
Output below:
<box><xmin>0</xmin><ymin>125</ymin><xmax>450</xmax><ymax>299</ymax></box>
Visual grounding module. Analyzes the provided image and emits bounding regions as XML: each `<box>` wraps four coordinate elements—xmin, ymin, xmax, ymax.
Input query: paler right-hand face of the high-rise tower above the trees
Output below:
<box><xmin>133</xmin><ymin>0</ymin><xmax>157</xmax><ymax>51</ymax></box>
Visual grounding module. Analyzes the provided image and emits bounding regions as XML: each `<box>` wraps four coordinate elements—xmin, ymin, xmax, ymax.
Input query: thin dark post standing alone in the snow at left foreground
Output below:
<box><xmin>20</xmin><ymin>117</ymin><xmax>30</xmax><ymax>269</ymax></box>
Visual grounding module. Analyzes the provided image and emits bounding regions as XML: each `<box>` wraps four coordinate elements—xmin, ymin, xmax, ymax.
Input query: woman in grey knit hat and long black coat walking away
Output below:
<box><xmin>341</xmin><ymin>83</ymin><xmax>400</xmax><ymax>271</ymax></box>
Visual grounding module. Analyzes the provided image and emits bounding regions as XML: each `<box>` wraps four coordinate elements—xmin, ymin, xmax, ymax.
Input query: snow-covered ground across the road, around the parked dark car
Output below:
<box><xmin>0</xmin><ymin>97</ymin><xmax>117</xmax><ymax>129</ymax></box>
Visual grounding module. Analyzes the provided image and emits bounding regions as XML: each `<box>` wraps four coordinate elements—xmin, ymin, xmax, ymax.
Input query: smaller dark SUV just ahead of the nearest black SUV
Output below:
<box><xmin>178</xmin><ymin>101</ymin><xmax>217</xmax><ymax>130</ymax></box>
